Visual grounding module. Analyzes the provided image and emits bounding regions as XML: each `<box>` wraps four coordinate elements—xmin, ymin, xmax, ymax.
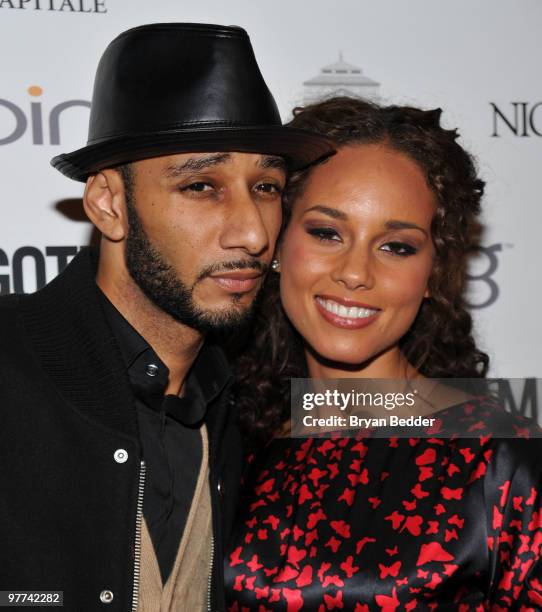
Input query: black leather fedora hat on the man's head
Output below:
<box><xmin>51</xmin><ymin>23</ymin><xmax>333</xmax><ymax>181</ymax></box>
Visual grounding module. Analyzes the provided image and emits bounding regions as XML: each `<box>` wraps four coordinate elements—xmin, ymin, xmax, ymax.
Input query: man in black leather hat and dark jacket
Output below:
<box><xmin>0</xmin><ymin>24</ymin><xmax>330</xmax><ymax>612</ymax></box>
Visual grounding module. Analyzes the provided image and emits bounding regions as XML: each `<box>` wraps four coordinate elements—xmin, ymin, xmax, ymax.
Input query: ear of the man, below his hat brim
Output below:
<box><xmin>83</xmin><ymin>169</ymin><xmax>128</xmax><ymax>242</ymax></box>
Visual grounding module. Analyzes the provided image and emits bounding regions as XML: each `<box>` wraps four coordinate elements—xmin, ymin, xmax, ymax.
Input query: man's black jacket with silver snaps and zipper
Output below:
<box><xmin>0</xmin><ymin>251</ymin><xmax>241</xmax><ymax>612</ymax></box>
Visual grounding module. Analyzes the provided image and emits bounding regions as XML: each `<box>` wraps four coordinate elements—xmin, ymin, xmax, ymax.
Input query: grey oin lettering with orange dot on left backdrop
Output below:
<box><xmin>0</xmin><ymin>86</ymin><xmax>90</xmax><ymax>145</ymax></box>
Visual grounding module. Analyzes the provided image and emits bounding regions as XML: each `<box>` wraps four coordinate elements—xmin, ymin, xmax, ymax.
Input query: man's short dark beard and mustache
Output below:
<box><xmin>125</xmin><ymin>194</ymin><xmax>267</xmax><ymax>335</ymax></box>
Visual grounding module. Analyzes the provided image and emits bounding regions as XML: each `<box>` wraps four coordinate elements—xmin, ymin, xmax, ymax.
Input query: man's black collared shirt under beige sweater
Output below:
<box><xmin>103</xmin><ymin>295</ymin><xmax>231</xmax><ymax>584</ymax></box>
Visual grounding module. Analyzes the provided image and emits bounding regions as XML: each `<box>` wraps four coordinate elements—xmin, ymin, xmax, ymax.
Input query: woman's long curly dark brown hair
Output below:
<box><xmin>234</xmin><ymin>97</ymin><xmax>489</xmax><ymax>446</ymax></box>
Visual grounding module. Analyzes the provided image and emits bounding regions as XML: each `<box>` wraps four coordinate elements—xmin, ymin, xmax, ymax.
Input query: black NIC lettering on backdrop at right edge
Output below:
<box><xmin>489</xmin><ymin>102</ymin><xmax>542</xmax><ymax>138</ymax></box>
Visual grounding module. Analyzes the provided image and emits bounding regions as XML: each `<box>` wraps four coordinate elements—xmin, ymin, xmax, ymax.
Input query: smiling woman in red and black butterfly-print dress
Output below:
<box><xmin>225</xmin><ymin>98</ymin><xmax>542</xmax><ymax>612</ymax></box>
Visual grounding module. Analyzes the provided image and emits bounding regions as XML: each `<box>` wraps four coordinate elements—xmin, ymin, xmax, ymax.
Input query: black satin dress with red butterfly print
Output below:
<box><xmin>225</xmin><ymin>399</ymin><xmax>542</xmax><ymax>612</ymax></box>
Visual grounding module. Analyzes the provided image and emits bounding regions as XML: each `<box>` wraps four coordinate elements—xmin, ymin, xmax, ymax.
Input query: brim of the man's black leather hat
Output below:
<box><xmin>51</xmin><ymin>126</ymin><xmax>335</xmax><ymax>181</ymax></box>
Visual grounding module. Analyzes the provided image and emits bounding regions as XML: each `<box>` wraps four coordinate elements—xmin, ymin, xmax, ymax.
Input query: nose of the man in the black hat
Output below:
<box><xmin>220</xmin><ymin>188</ymin><xmax>276</xmax><ymax>257</ymax></box>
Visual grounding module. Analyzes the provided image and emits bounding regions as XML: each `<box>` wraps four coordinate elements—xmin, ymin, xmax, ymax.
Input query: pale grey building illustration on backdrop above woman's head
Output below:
<box><xmin>303</xmin><ymin>53</ymin><xmax>380</xmax><ymax>104</ymax></box>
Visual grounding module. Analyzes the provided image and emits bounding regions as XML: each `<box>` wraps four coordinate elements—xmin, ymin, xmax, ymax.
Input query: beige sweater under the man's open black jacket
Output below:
<box><xmin>137</xmin><ymin>426</ymin><xmax>212</xmax><ymax>612</ymax></box>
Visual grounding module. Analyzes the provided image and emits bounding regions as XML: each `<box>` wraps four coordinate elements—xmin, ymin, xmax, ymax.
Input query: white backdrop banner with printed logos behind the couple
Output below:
<box><xmin>0</xmin><ymin>0</ymin><xmax>542</xmax><ymax>378</ymax></box>
